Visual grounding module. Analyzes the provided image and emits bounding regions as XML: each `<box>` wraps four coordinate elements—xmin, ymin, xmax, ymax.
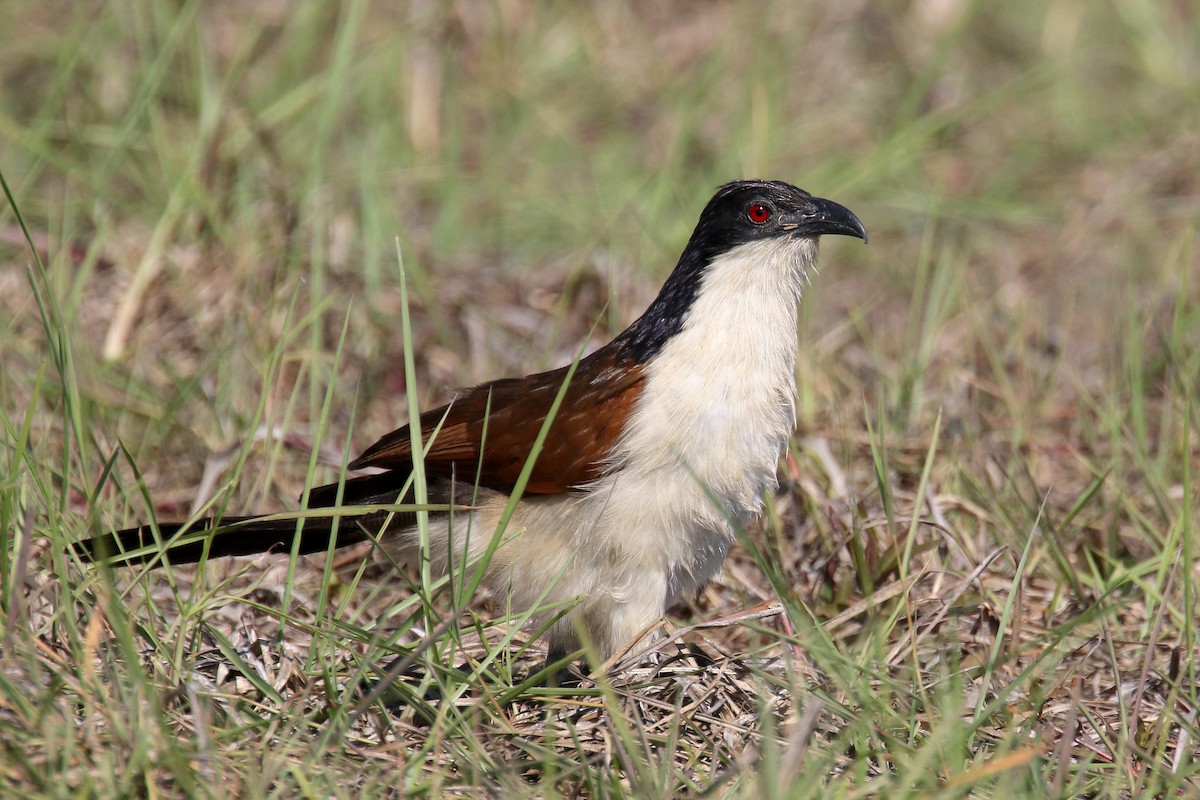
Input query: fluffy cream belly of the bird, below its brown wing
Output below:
<box><xmin>384</xmin><ymin>489</ymin><xmax>733</xmax><ymax>657</ymax></box>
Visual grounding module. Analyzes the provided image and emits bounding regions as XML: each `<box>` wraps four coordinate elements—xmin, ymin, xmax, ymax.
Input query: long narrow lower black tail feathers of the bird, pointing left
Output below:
<box><xmin>74</xmin><ymin>517</ymin><xmax>367</xmax><ymax>564</ymax></box>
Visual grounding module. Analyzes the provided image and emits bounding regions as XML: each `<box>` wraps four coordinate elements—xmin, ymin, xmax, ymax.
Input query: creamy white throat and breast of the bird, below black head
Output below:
<box><xmin>596</xmin><ymin>231</ymin><xmax>816</xmax><ymax>594</ymax></box>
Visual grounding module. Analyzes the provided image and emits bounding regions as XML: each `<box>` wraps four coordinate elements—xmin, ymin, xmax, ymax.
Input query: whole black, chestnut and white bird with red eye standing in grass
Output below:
<box><xmin>74</xmin><ymin>180</ymin><xmax>868</xmax><ymax>663</ymax></box>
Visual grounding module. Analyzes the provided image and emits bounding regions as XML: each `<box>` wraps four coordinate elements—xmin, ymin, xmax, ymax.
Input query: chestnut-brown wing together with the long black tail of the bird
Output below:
<box><xmin>76</xmin><ymin>348</ymin><xmax>644</xmax><ymax>564</ymax></box>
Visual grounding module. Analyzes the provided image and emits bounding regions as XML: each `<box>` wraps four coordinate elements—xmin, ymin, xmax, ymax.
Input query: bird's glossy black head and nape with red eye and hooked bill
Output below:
<box><xmin>612</xmin><ymin>180</ymin><xmax>866</xmax><ymax>363</ymax></box>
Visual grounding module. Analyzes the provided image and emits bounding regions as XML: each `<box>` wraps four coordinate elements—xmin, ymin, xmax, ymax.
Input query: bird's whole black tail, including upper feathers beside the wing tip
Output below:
<box><xmin>73</xmin><ymin>471</ymin><xmax>422</xmax><ymax>564</ymax></box>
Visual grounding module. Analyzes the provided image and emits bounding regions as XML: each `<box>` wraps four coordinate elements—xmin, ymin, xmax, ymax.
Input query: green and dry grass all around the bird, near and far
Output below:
<box><xmin>0</xmin><ymin>0</ymin><xmax>1200</xmax><ymax>798</ymax></box>
